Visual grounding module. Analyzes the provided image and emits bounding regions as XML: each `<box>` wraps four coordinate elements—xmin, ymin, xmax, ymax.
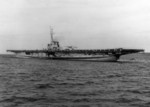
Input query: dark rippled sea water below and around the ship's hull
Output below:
<box><xmin>0</xmin><ymin>54</ymin><xmax>150</xmax><ymax>107</ymax></box>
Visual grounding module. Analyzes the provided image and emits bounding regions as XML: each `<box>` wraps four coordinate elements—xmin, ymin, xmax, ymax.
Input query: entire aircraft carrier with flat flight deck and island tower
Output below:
<box><xmin>7</xmin><ymin>28</ymin><xmax>144</xmax><ymax>62</ymax></box>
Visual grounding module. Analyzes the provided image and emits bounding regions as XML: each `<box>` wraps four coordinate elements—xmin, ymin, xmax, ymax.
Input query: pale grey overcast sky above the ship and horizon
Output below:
<box><xmin>0</xmin><ymin>0</ymin><xmax>150</xmax><ymax>53</ymax></box>
